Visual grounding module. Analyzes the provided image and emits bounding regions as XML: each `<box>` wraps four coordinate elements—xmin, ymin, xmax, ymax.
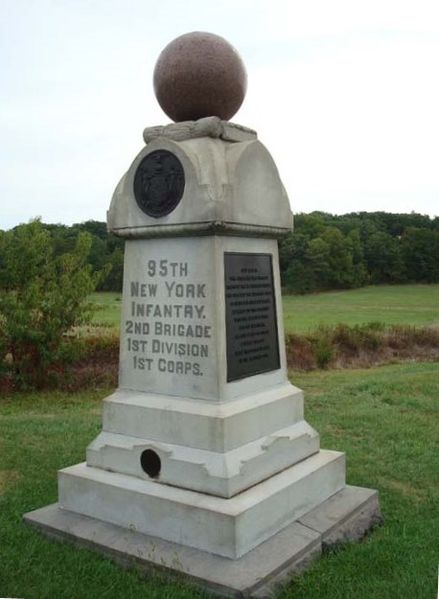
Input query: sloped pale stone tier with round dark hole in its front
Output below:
<box><xmin>87</xmin><ymin>420</ymin><xmax>319</xmax><ymax>497</ymax></box>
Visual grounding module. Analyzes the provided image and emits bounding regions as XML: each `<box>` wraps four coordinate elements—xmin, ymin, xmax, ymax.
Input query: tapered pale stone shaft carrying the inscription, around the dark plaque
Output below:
<box><xmin>119</xmin><ymin>236</ymin><xmax>288</xmax><ymax>400</ymax></box>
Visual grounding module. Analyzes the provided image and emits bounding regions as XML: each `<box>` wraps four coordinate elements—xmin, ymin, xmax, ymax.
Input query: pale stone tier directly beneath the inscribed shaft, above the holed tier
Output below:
<box><xmin>99</xmin><ymin>383</ymin><xmax>303</xmax><ymax>453</ymax></box>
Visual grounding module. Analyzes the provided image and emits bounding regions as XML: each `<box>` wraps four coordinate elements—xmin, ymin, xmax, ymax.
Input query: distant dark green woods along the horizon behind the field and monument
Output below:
<box><xmin>0</xmin><ymin>212</ymin><xmax>439</xmax><ymax>293</ymax></box>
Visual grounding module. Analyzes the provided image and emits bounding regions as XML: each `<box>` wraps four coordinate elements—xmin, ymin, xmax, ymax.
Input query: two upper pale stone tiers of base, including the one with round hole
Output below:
<box><xmin>86</xmin><ymin>383</ymin><xmax>320</xmax><ymax>496</ymax></box>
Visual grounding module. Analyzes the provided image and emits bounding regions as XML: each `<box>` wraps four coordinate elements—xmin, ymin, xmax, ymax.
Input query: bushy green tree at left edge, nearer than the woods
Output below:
<box><xmin>0</xmin><ymin>221</ymin><xmax>102</xmax><ymax>387</ymax></box>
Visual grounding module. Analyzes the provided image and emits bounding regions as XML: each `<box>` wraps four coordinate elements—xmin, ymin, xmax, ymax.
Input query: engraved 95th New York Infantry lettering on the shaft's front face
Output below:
<box><xmin>123</xmin><ymin>259</ymin><xmax>212</xmax><ymax>377</ymax></box>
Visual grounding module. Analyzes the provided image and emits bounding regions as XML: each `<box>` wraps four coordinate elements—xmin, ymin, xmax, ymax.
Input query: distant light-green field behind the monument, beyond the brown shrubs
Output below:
<box><xmin>91</xmin><ymin>285</ymin><xmax>439</xmax><ymax>332</ymax></box>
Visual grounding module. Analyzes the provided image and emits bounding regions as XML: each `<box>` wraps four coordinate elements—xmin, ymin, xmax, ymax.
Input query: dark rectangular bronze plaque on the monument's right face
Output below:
<box><xmin>224</xmin><ymin>252</ymin><xmax>280</xmax><ymax>382</ymax></box>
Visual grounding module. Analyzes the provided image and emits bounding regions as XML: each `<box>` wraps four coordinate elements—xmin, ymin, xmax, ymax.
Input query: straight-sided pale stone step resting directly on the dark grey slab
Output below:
<box><xmin>58</xmin><ymin>450</ymin><xmax>345</xmax><ymax>559</ymax></box>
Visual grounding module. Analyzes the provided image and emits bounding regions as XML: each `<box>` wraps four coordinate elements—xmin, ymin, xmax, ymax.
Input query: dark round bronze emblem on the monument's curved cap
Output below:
<box><xmin>134</xmin><ymin>150</ymin><xmax>184</xmax><ymax>218</ymax></box>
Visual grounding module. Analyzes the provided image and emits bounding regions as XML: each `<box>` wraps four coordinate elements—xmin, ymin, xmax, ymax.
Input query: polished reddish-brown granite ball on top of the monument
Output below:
<box><xmin>154</xmin><ymin>31</ymin><xmax>247</xmax><ymax>122</ymax></box>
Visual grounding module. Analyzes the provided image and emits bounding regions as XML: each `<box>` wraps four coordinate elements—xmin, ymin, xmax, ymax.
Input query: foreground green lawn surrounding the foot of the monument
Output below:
<box><xmin>0</xmin><ymin>363</ymin><xmax>439</xmax><ymax>599</ymax></box>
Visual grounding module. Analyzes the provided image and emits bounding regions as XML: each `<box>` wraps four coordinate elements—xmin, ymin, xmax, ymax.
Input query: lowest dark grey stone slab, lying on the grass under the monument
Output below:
<box><xmin>24</xmin><ymin>486</ymin><xmax>382</xmax><ymax>599</ymax></box>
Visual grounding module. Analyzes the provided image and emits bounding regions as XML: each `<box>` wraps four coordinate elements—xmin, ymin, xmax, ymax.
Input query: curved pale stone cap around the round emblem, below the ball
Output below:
<box><xmin>107</xmin><ymin>137</ymin><xmax>293</xmax><ymax>239</ymax></box>
